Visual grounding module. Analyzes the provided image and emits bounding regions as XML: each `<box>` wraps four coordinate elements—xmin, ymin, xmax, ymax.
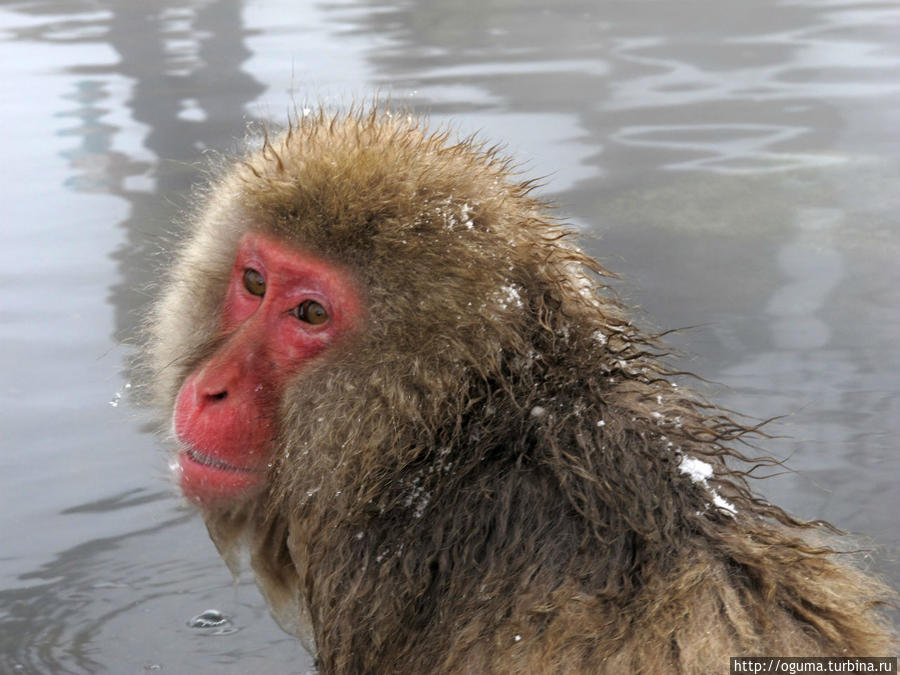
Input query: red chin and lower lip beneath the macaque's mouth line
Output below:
<box><xmin>172</xmin><ymin>445</ymin><xmax>266</xmax><ymax>509</ymax></box>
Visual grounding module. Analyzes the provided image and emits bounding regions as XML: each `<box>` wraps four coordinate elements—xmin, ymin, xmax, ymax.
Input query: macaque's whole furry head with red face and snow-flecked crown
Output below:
<box><xmin>149</xmin><ymin>113</ymin><xmax>576</xmax><ymax>511</ymax></box>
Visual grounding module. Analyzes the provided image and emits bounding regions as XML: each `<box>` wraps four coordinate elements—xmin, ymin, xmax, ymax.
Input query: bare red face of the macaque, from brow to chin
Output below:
<box><xmin>174</xmin><ymin>233</ymin><xmax>362</xmax><ymax>506</ymax></box>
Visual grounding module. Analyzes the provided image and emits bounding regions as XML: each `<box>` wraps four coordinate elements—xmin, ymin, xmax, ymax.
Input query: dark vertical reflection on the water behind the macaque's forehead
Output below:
<box><xmin>108</xmin><ymin>0</ymin><xmax>262</xmax><ymax>339</ymax></box>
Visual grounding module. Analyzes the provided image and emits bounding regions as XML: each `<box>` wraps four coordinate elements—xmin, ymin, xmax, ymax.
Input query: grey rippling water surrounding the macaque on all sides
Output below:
<box><xmin>0</xmin><ymin>0</ymin><xmax>900</xmax><ymax>674</ymax></box>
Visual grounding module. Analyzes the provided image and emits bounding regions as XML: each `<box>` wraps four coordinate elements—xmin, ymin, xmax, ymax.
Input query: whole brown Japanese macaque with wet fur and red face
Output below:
<box><xmin>147</xmin><ymin>111</ymin><xmax>896</xmax><ymax>674</ymax></box>
